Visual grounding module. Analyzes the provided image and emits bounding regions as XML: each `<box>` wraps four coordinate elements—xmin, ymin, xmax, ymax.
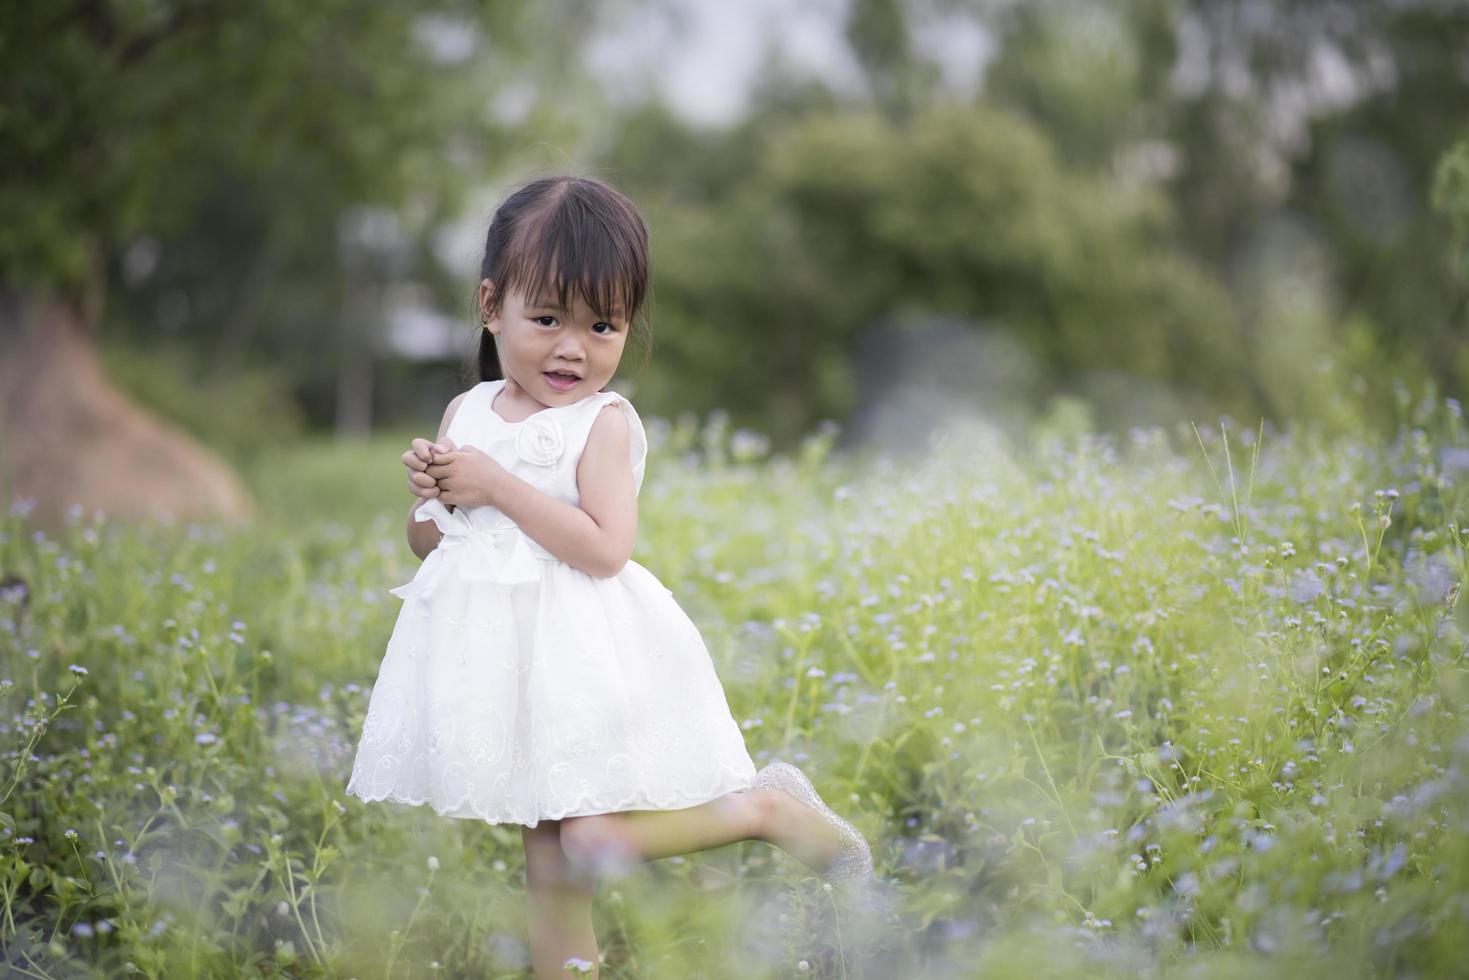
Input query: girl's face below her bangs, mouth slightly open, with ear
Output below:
<box><xmin>479</xmin><ymin>279</ymin><xmax>630</xmax><ymax>407</ymax></box>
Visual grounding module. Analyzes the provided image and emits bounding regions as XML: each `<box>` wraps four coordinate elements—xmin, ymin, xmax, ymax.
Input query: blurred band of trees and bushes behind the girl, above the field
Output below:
<box><xmin>0</xmin><ymin>0</ymin><xmax>1469</xmax><ymax>461</ymax></box>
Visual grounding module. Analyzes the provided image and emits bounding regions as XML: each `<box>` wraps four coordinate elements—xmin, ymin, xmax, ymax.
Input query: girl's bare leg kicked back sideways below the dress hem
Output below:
<box><xmin>561</xmin><ymin>789</ymin><xmax>842</xmax><ymax>874</ymax></box>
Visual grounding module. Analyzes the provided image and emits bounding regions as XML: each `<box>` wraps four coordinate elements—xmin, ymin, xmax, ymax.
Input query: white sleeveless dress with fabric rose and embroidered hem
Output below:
<box><xmin>347</xmin><ymin>381</ymin><xmax>755</xmax><ymax>827</ymax></box>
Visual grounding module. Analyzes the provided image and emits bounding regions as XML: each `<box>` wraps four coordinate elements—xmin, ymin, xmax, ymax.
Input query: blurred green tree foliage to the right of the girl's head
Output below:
<box><xmin>610</xmin><ymin>0</ymin><xmax>1469</xmax><ymax>429</ymax></box>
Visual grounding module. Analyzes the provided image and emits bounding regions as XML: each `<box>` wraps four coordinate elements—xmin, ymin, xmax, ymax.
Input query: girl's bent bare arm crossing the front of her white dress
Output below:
<box><xmin>489</xmin><ymin>404</ymin><xmax>638</xmax><ymax>579</ymax></box>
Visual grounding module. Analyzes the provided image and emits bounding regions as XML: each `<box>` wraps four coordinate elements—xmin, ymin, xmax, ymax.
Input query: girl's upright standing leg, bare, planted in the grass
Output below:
<box><xmin>520</xmin><ymin>820</ymin><xmax>601</xmax><ymax>980</ymax></box>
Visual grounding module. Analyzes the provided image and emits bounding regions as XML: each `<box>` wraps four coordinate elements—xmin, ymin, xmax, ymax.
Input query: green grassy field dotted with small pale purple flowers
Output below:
<box><xmin>0</xmin><ymin>400</ymin><xmax>1469</xmax><ymax>980</ymax></box>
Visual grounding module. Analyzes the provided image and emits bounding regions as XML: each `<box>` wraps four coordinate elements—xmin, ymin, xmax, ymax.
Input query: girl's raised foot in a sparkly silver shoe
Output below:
<box><xmin>751</xmin><ymin>758</ymin><xmax>873</xmax><ymax>882</ymax></box>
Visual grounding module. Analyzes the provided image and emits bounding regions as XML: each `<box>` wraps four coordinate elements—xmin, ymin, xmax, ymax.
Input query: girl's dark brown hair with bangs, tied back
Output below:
<box><xmin>476</xmin><ymin>175</ymin><xmax>649</xmax><ymax>381</ymax></box>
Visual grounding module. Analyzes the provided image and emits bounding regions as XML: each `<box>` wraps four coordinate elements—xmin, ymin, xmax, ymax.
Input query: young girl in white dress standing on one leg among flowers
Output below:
<box><xmin>347</xmin><ymin>176</ymin><xmax>873</xmax><ymax>977</ymax></box>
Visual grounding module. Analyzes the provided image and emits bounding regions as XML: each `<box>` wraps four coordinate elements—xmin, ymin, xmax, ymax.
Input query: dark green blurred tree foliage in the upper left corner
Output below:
<box><xmin>0</xmin><ymin>0</ymin><xmax>572</xmax><ymax>299</ymax></box>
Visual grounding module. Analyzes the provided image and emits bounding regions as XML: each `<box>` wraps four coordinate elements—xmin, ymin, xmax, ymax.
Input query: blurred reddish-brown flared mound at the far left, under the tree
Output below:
<box><xmin>0</xmin><ymin>292</ymin><xmax>256</xmax><ymax>530</ymax></box>
